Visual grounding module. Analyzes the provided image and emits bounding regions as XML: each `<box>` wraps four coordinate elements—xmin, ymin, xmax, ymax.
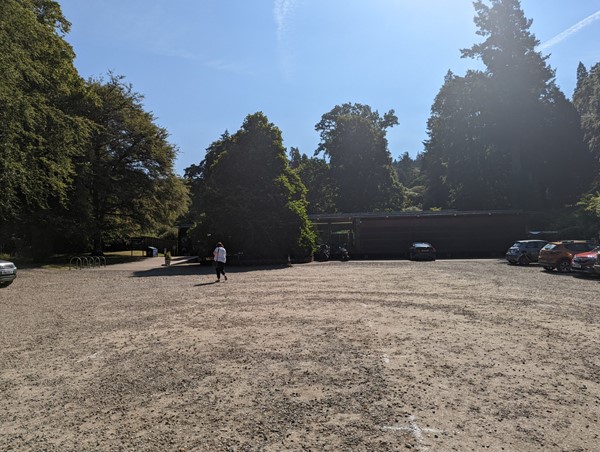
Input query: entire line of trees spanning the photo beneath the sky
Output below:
<box><xmin>0</xmin><ymin>0</ymin><xmax>600</xmax><ymax>260</ymax></box>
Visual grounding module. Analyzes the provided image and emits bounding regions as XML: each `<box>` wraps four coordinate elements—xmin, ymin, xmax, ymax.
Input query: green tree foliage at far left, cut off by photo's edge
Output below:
<box><xmin>0</xmin><ymin>0</ymin><xmax>86</xmax><ymax>221</ymax></box>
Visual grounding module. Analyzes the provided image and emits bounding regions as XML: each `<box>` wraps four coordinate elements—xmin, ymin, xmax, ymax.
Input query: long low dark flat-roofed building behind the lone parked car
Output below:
<box><xmin>309</xmin><ymin>211</ymin><xmax>531</xmax><ymax>259</ymax></box>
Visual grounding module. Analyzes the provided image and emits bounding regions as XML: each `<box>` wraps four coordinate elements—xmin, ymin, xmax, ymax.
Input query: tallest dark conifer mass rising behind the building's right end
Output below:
<box><xmin>423</xmin><ymin>0</ymin><xmax>590</xmax><ymax>209</ymax></box>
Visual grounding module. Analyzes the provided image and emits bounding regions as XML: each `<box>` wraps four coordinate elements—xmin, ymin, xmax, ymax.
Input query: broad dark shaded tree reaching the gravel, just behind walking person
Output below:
<box><xmin>186</xmin><ymin>113</ymin><xmax>315</xmax><ymax>260</ymax></box>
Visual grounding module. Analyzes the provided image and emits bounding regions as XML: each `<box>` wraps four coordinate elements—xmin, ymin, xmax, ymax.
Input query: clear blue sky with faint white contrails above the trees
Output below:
<box><xmin>58</xmin><ymin>0</ymin><xmax>600</xmax><ymax>174</ymax></box>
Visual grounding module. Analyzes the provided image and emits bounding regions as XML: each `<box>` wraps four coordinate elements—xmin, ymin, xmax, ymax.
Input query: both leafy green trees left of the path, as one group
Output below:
<box><xmin>0</xmin><ymin>0</ymin><xmax>188</xmax><ymax>257</ymax></box>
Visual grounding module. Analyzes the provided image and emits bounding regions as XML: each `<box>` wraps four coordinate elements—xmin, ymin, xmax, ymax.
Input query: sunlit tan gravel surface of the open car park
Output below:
<box><xmin>0</xmin><ymin>258</ymin><xmax>600</xmax><ymax>451</ymax></box>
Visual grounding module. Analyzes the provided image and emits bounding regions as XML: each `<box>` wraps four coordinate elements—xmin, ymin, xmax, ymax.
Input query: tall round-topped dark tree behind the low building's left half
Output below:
<box><xmin>315</xmin><ymin>103</ymin><xmax>404</xmax><ymax>212</ymax></box>
